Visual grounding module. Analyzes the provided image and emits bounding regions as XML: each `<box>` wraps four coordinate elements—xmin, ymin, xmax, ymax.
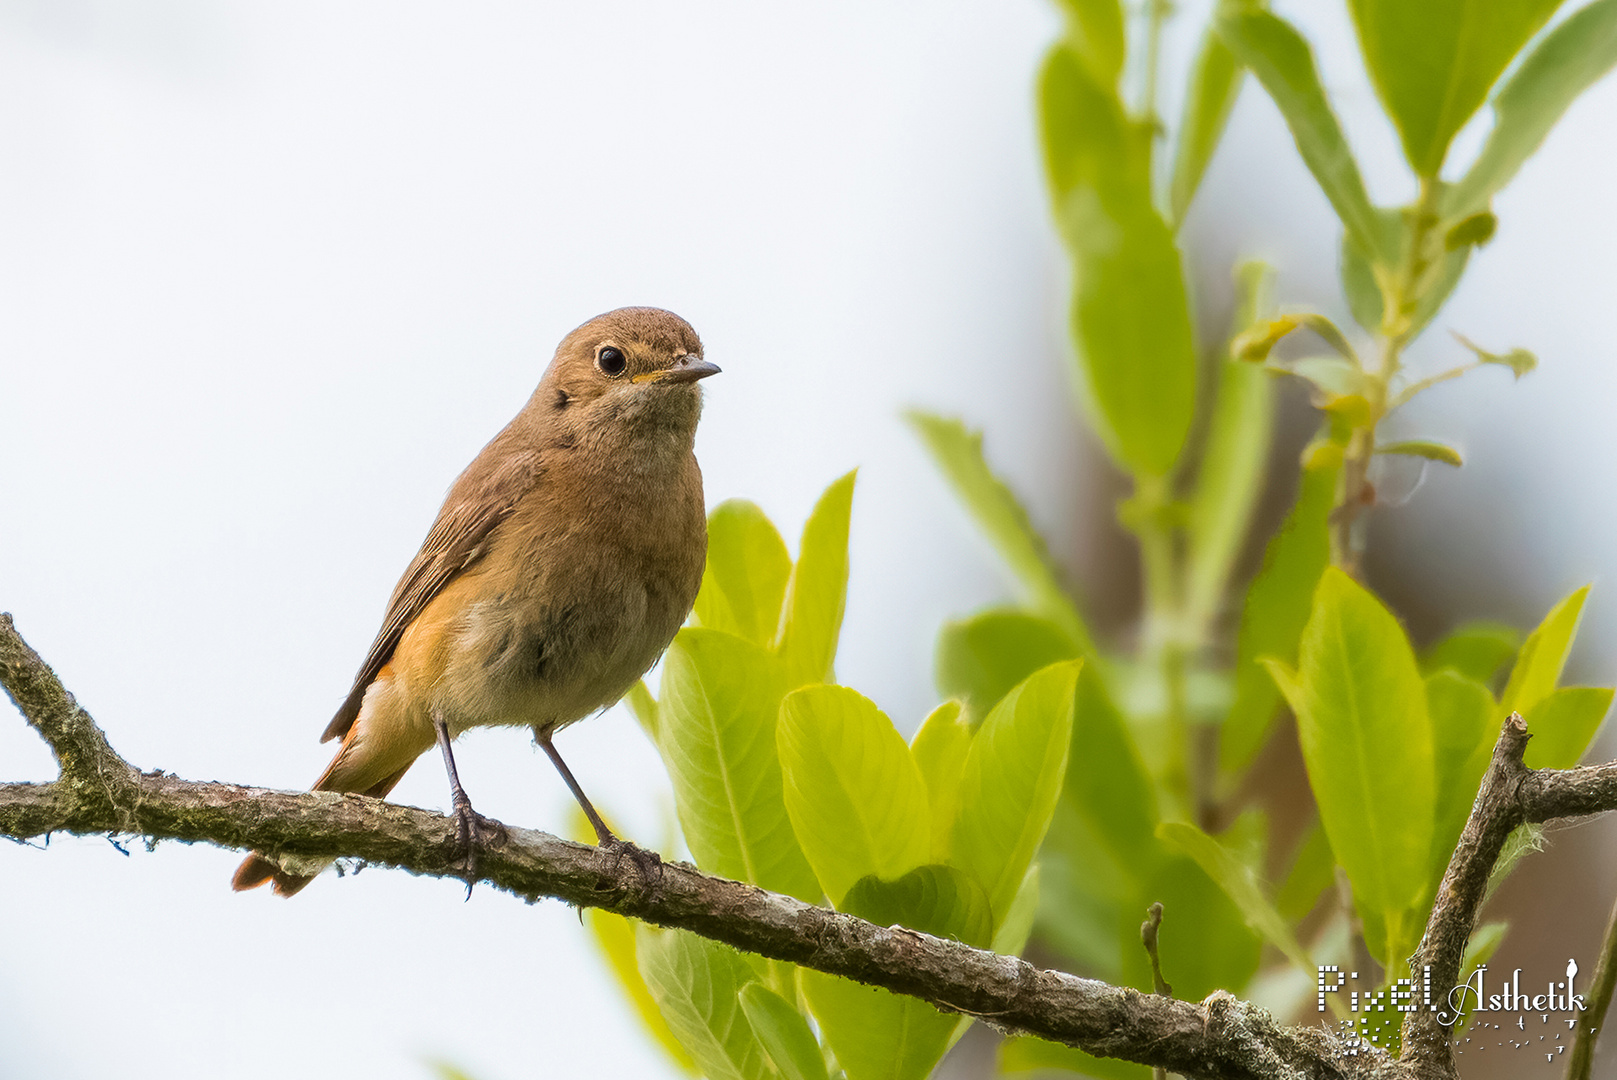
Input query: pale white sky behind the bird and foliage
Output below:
<box><xmin>0</xmin><ymin>0</ymin><xmax>1617</xmax><ymax>1080</ymax></box>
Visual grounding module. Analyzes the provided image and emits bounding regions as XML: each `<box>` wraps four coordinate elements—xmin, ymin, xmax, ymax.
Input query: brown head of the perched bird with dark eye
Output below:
<box><xmin>534</xmin><ymin>307</ymin><xmax>720</xmax><ymax>437</ymax></box>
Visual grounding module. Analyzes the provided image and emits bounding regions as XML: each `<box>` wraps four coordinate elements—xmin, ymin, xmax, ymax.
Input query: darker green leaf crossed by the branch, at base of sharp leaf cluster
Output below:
<box><xmin>799</xmin><ymin>867</ymin><xmax>991</xmax><ymax>1080</ymax></box>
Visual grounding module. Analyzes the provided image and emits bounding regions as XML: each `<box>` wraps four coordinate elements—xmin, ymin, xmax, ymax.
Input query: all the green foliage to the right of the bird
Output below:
<box><xmin>590</xmin><ymin>0</ymin><xmax>1617</xmax><ymax>1080</ymax></box>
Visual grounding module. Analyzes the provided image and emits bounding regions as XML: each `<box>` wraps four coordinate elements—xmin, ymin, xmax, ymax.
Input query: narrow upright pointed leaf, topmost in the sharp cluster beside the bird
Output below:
<box><xmin>778</xmin><ymin>470</ymin><xmax>857</xmax><ymax>687</ymax></box>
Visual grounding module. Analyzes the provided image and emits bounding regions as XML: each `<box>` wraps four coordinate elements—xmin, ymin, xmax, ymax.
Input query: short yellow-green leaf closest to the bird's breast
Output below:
<box><xmin>695</xmin><ymin>500</ymin><xmax>792</xmax><ymax>648</ymax></box>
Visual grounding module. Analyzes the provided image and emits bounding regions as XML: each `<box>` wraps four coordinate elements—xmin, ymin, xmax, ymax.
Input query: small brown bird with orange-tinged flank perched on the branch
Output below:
<box><xmin>233</xmin><ymin>307</ymin><xmax>720</xmax><ymax>896</ymax></box>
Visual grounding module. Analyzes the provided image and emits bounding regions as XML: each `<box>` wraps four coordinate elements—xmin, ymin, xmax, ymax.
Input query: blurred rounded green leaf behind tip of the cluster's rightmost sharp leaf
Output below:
<box><xmin>938</xmin><ymin>608</ymin><xmax>1079</xmax><ymax>721</ymax></box>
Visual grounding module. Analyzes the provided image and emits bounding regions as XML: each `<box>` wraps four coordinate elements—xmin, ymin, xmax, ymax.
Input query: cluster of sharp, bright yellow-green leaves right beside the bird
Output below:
<box><xmin>589</xmin><ymin>470</ymin><xmax>1082</xmax><ymax>1080</ymax></box>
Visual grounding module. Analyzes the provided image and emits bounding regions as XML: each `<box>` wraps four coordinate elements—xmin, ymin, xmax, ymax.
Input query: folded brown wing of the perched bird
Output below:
<box><xmin>320</xmin><ymin>445</ymin><xmax>538</xmax><ymax>742</ymax></box>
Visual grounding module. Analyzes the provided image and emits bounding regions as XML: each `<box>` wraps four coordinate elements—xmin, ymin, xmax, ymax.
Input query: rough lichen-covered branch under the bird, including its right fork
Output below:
<box><xmin>0</xmin><ymin>614</ymin><xmax>1617</xmax><ymax>1080</ymax></box>
